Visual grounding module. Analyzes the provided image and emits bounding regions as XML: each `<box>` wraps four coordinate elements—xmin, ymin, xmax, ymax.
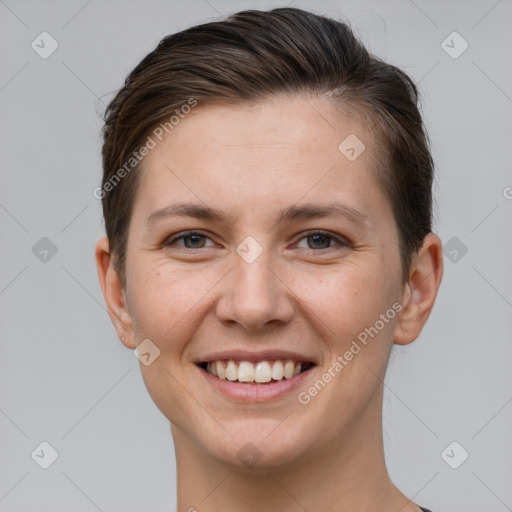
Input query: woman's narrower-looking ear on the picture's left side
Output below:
<box><xmin>95</xmin><ymin>237</ymin><xmax>136</xmax><ymax>349</ymax></box>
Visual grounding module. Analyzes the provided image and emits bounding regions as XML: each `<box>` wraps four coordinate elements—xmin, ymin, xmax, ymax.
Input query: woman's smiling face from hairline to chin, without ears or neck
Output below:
<box><xmin>116</xmin><ymin>97</ymin><xmax>403</xmax><ymax>467</ymax></box>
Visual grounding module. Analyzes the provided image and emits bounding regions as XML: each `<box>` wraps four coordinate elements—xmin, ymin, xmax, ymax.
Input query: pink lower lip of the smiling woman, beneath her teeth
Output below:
<box><xmin>197</xmin><ymin>366</ymin><xmax>314</xmax><ymax>402</ymax></box>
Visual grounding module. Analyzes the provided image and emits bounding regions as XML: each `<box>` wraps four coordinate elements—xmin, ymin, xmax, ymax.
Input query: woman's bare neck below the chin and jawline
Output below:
<box><xmin>172</xmin><ymin>390</ymin><xmax>420</xmax><ymax>512</ymax></box>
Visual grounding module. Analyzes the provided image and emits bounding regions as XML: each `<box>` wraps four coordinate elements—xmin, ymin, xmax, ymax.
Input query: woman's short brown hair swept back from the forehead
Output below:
<box><xmin>102</xmin><ymin>8</ymin><xmax>433</xmax><ymax>285</ymax></box>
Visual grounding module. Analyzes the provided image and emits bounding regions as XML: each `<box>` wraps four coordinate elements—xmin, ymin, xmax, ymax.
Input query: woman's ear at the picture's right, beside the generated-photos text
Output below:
<box><xmin>393</xmin><ymin>233</ymin><xmax>443</xmax><ymax>345</ymax></box>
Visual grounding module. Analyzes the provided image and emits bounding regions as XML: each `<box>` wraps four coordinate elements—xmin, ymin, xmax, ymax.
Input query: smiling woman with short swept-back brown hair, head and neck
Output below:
<box><xmin>96</xmin><ymin>8</ymin><xmax>442</xmax><ymax>512</ymax></box>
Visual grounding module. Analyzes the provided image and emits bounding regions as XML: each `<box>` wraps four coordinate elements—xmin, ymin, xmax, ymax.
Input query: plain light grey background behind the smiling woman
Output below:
<box><xmin>0</xmin><ymin>0</ymin><xmax>512</xmax><ymax>512</ymax></box>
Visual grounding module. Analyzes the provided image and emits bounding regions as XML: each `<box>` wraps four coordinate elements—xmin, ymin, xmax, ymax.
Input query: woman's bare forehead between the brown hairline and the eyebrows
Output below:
<box><xmin>131</xmin><ymin>95</ymin><xmax>383</xmax><ymax>226</ymax></box>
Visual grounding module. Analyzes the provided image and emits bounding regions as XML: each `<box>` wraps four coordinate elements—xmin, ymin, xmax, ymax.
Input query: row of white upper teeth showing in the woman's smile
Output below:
<box><xmin>206</xmin><ymin>359</ymin><xmax>302</xmax><ymax>382</ymax></box>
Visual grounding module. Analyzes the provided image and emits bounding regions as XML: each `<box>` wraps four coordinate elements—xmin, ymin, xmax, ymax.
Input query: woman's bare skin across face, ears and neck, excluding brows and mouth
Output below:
<box><xmin>96</xmin><ymin>96</ymin><xmax>442</xmax><ymax>512</ymax></box>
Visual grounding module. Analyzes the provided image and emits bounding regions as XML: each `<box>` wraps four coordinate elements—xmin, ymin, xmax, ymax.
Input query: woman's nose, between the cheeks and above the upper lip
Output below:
<box><xmin>216</xmin><ymin>251</ymin><xmax>294</xmax><ymax>331</ymax></box>
